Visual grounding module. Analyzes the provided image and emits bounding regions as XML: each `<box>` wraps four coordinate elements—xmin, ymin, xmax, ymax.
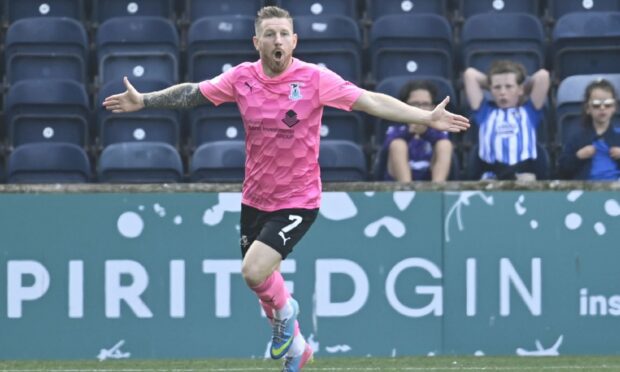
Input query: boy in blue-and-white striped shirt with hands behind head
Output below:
<box><xmin>463</xmin><ymin>60</ymin><xmax>550</xmax><ymax>180</ymax></box>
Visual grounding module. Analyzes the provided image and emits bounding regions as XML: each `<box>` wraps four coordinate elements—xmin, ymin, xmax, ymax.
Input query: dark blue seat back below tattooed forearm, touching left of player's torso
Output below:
<box><xmin>188</xmin><ymin>103</ymin><xmax>245</xmax><ymax>150</ymax></box>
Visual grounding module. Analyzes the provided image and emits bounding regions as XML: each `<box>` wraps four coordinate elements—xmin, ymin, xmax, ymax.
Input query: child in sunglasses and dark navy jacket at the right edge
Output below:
<box><xmin>559</xmin><ymin>79</ymin><xmax>620</xmax><ymax>181</ymax></box>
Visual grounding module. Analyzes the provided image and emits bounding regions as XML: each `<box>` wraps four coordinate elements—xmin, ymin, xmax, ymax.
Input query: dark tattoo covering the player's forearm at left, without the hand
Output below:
<box><xmin>144</xmin><ymin>83</ymin><xmax>208</xmax><ymax>109</ymax></box>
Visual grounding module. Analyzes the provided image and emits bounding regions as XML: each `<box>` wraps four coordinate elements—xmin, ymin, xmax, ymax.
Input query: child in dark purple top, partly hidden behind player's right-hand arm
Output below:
<box><xmin>382</xmin><ymin>80</ymin><xmax>452</xmax><ymax>182</ymax></box>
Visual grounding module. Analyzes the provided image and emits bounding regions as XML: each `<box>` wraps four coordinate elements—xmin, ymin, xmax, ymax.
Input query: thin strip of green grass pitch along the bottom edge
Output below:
<box><xmin>0</xmin><ymin>356</ymin><xmax>620</xmax><ymax>372</ymax></box>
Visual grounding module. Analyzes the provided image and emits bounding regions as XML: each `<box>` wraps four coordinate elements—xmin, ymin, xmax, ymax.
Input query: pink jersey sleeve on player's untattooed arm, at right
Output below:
<box><xmin>319</xmin><ymin>68</ymin><xmax>363</xmax><ymax>111</ymax></box>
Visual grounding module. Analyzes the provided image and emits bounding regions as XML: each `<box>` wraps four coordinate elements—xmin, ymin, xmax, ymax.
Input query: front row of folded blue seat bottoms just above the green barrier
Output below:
<box><xmin>0</xmin><ymin>140</ymin><xmax>368</xmax><ymax>183</ymax></box>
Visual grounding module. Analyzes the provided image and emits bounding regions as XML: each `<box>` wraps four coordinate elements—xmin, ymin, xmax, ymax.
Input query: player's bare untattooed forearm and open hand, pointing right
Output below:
<box><xmin>353</xmin><ymin>91</ymin><xmax>469</xmax><ymax>132</ymax></box>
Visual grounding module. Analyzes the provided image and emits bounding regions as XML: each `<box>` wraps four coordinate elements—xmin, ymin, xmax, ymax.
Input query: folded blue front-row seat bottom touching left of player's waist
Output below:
<box><xmin>190</xmin><ymin>141</ymin><xmax>245</xmax><ymax>182</ymax></box>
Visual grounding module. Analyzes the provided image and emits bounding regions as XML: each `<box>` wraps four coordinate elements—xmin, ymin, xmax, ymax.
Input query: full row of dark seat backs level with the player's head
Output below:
<box><xmin>4</xmin><ymin>11</ymin><xmax>620</xmax><ymax>86</ymax></box>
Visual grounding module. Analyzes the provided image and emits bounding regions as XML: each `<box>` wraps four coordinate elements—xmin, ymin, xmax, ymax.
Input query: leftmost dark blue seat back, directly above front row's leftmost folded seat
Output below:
<box><xmin>5</xmin><ymin>79</ymin><xmax>90</xmax><ymax>147</ymax></box>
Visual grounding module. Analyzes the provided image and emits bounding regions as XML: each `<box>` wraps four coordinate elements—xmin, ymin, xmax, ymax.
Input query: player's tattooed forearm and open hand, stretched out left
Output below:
<box><xmin>103</xmin><ymin>77</ymin><xmax>208</xmax><ymax>113</ymax></box>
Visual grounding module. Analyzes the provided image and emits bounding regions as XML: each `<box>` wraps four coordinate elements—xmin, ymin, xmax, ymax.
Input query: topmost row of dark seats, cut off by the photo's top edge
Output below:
<box><xmin>0</xmin><ymin>0</ymin><xmax>620</xmax><ymax>24</ymax></box>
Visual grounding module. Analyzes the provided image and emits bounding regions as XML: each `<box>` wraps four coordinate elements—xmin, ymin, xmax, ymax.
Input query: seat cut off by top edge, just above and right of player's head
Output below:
<box><xmin>276</xmin><ymin>0</ymin><xmax>358</xmax><ymax>19</ymax></box>
